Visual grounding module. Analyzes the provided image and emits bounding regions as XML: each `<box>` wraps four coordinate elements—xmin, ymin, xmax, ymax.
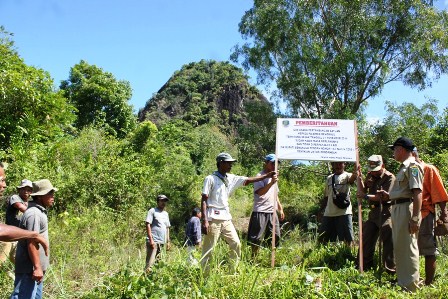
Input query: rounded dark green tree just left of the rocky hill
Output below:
<box><xmin>60</xmin><ymin>60</ymin><xmax>136</xmax><ymax>138</ymax></box>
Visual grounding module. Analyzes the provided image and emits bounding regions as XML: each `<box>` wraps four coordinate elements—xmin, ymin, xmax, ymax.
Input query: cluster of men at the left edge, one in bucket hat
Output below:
<box><xmin>0</xmin><ymin>165</ymin><xmax>58</xmax><ymax>299</ymax></box>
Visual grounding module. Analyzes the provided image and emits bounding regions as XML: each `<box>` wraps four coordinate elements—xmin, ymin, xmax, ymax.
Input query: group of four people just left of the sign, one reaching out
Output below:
<box><xmin>145</xmin><ymin>153</ymin><xmax>285</xmax><ymax>275</ymax></box>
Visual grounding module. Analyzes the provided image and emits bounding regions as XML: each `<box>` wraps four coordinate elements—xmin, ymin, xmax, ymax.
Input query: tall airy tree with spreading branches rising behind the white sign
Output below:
<box><xmin>232</xmin><ymin>0</ymin><xmax>448</xmax><ymax>118</ymax></box>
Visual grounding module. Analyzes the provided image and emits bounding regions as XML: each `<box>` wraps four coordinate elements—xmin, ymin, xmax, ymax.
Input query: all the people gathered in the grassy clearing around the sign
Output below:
<box><xmin>5</xmin><ymin>137</ymin><xmax>448</xmax><ymax>298</ymax></box>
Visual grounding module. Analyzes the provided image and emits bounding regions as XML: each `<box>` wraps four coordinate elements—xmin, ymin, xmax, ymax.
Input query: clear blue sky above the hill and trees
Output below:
<box><xmin>0</xmin><ymin>0</ymin><xmax>448</xmax><ymax>120</ymax></box>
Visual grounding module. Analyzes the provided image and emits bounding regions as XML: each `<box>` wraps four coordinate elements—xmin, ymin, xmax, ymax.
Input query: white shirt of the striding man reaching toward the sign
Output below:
<box><xmin>202</xmin><ymin>171</ymin><xmax>247</xmax><ymax>221</ymax></box>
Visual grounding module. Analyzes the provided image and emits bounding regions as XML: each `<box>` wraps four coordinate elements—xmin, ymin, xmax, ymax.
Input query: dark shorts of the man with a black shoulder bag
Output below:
<box><xmin>319</xmin><ymin>214</ymin><xmax>354</xmax><ymax>242</ymax></box>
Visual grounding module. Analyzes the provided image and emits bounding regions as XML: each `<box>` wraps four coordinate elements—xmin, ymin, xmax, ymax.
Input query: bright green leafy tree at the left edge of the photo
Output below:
<box><xmin>0</xmin><ymin>27</ymin><xmax>75</xmax><ymax>149</ymax></box>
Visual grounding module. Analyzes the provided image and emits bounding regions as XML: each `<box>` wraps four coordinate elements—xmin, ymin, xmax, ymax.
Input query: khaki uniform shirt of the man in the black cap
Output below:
<box><xmin>389</xmin><ymin>157</ymin><xmax>423</xmax><ymax>200</ymax></box>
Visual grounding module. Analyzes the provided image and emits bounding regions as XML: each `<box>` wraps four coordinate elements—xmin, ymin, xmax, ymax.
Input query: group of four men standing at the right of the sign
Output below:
<box><xmin>320</xmin><ymin>137</ymin><xmax>448</xmax><ymax>292</ymax></box>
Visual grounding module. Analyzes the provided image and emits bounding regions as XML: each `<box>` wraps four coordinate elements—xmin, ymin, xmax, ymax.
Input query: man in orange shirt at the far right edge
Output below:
<box><xmin>412</xmin><ymin>148</ymin><xmax>448</xmax><ymax>285</ymax></box>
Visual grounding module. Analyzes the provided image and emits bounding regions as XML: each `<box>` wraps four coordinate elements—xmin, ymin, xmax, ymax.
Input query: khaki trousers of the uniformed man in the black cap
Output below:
<box><xmin>391</xmin><ymin>203</ymin><xmax>420</xmax><ymax>292</ymax></box>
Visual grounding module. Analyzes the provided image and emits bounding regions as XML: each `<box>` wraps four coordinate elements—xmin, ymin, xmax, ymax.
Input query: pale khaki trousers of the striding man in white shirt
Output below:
<box><xmin>201</xmin><ymin>219</ymin><xmax>241</xmax><ymax>275</ymax></box>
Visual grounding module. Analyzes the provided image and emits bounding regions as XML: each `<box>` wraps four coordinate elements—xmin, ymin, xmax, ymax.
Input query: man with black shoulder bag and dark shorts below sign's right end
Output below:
<box><xmin>319</xmin><ymin>162</ymin><xmax>358</xmax><ymax>246</ymax></box>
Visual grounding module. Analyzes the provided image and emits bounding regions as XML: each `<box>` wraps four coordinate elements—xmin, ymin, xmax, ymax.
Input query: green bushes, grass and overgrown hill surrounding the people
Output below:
<box><xmin>0</xmin><ymin>1</ymin><xmax>448</xmax><ymax>299</ymax></box>
